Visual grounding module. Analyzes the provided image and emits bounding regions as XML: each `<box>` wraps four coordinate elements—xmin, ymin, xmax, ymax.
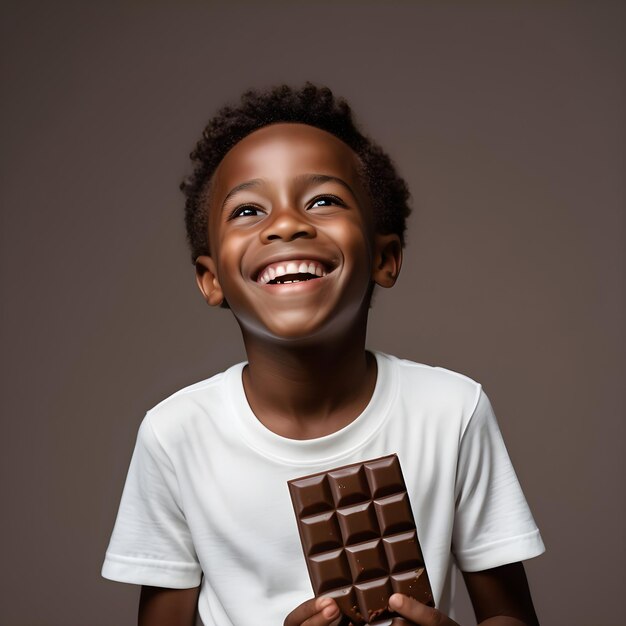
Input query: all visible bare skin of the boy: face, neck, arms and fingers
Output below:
<box><xmin>139</xmin><ymin>124</ymin><xmax>538</xmax><ymax>626</ymax></box>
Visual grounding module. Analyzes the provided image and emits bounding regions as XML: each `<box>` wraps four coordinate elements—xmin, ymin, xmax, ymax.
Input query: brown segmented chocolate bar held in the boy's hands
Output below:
<box><xmin>288</xmin><ymin>454</ymin><xmax>434</xmax><ymax>626</ymax></box>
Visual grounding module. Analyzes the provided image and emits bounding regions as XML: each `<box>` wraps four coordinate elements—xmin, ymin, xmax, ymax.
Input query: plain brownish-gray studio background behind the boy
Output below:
<box><xmin>0</xmin><ymin>1</ymin><xmax>626</xmax><ymax>626</ymax></box>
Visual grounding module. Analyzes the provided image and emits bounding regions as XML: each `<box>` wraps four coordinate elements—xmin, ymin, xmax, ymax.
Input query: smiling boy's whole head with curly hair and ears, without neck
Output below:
<box><xmin>186</xmin><ymin>86</ymin><xmax>408</xmax><ymax>341</ymax></box>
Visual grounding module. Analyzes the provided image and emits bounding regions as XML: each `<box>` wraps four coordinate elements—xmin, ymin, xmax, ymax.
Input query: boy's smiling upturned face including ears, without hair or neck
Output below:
<box><xmin>196</xmin><ymin>123</ymin><xmax>401</xmax><ymax>339</ymax></box>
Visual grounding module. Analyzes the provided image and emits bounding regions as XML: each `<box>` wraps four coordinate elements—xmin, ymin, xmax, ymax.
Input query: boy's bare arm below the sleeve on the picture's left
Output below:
<box><xmin>137</xmin><ymin>586</ymin><xmax>200</xmax><ymax>626</ymax></box>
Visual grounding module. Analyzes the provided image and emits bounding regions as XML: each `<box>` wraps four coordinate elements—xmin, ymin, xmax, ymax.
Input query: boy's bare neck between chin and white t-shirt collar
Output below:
<box><xmin>243</xmin><ymin>325</ymin><xmax>376</xmax><ymax>439</ymax></box>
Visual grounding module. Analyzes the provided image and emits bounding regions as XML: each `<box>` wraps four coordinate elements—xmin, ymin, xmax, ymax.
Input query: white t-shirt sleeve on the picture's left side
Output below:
<box><xmin>102</xmin><ymin>414</ymin><xmax>201</xmax><ymax>589</ymax></box>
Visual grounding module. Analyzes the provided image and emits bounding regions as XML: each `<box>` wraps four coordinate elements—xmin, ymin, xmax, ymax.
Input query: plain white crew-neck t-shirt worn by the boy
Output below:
<box><xmin>102</xmin><ymin>353</ymin><xmax>544</xmax><ymax>626</ymax></box>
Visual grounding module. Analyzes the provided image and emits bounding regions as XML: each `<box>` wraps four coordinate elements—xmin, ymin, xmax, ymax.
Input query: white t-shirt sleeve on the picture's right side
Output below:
<box><xmin>452</xmin><ymin>391</ymin><xmax>545</xmax><ymax>572</ymax></box>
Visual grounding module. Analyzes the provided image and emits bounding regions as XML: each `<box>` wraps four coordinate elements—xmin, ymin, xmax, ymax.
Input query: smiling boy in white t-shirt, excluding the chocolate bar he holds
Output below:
<box><xmin>103</xmin><ymin>84</ymin><xmax>543</xmax><ymax>626</ymax></box>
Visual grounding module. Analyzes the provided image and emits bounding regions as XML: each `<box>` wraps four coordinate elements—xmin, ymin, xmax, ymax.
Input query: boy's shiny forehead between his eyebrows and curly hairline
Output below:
<box><xmin>211</xmin><ymin>123</ymin><xmax>360</xmax><ymax>199</ymax></box>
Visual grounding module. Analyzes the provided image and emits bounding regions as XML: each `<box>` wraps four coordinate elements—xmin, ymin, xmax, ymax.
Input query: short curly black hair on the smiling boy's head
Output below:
<box><xmin>180</xmin><ymin>83</ymin><xmax>411</xmax><ymax>263</ymax></box>
